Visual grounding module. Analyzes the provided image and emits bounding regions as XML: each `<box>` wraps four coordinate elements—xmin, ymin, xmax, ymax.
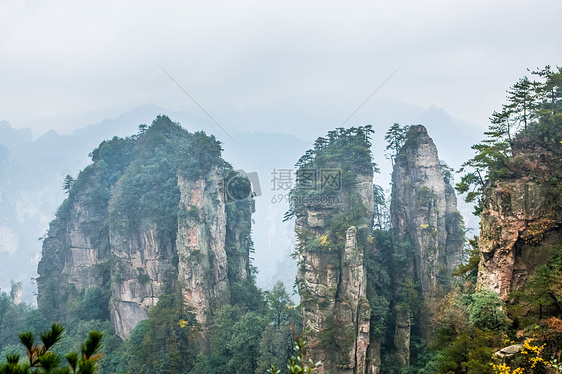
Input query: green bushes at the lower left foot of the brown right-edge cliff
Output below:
<box><xmin>420</xmin><ymin>248</ymin><xmax>511</xmax><ymax>374</ymax></box>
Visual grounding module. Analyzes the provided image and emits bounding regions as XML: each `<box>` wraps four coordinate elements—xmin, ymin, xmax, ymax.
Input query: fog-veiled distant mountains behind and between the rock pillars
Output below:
<box><xmin>0</xmin><ymin>98</ymin><xmax>482</xmax><ymax>301</ymax></box>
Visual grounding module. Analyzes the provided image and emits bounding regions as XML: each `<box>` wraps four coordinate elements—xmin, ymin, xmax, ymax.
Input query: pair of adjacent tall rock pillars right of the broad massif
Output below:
<box><xmin>291</xmin><ymin>125</ymin><xmax>464</xmax><ymax>374</ymax></box>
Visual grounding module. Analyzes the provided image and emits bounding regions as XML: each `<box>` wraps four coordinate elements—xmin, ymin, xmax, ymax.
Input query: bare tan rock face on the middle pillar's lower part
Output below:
<box><xmin>295</xmin><ymin>175</ymin><xmax>373</xmax><ymax>373</ymax></box>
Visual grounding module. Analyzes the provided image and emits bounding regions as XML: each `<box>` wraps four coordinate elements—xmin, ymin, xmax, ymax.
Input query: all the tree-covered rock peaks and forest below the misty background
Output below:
<box><xmin>0</xmin><ymin>67</ymin><xmax>562</xmax><ymax>374</ymax></box>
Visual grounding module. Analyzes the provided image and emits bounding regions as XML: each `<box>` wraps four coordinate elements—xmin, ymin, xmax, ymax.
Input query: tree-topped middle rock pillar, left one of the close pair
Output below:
<box><xmin>292</xmin><ymin>129</ymin><xmax>378</xmax><ymax>373</ymax></box>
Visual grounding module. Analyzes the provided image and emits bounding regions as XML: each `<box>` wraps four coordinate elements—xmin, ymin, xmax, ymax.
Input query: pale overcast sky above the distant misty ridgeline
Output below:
<box><xmin>0</xmin><ymin>0</ymin><xmax>562</xmax><ymax>134</ymax></box>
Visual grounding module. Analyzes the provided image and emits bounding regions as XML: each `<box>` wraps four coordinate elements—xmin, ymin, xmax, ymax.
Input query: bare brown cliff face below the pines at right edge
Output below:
<box><xmin>477</xmin><ymin>177</ymin><xmax>562</xmax><ymax>301</ymax></box>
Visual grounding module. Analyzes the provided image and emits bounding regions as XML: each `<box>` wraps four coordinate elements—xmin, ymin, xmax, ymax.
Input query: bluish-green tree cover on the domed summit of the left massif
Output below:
<box><xmin>101</xmin><ymin>116</ymin><xmax>226</xmax><ymax>245</ymax></box>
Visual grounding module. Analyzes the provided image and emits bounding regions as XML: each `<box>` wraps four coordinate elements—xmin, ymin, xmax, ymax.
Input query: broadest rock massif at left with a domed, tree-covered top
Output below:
<box><xmin>37</xmin><ymin>116</ymin><xmax>253</xmax><ymax>343</ymax></box>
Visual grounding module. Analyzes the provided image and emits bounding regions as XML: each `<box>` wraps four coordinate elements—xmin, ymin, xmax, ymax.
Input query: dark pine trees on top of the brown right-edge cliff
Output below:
<box><xmin>456</xmin><ymin>66</ymin><xmax>562</xmax><ymax>215</ymax></box>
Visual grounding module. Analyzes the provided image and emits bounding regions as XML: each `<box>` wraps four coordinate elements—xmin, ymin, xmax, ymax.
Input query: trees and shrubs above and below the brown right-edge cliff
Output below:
<box><xmin>422</xmin><ymin>66</ymin><xmax>562</xmax><ymax>374</ymax></box>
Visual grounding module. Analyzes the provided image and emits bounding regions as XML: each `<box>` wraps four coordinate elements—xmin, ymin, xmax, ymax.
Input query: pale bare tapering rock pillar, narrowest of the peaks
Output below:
<box><xmin>391</xmin><ymin>125</ymin><xmax>464</xmax><ymax>294</ymax></box>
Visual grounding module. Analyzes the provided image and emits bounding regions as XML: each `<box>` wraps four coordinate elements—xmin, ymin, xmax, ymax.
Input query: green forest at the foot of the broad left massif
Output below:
<box><xmin>0</xmin><ymin>283</ymin><xmax>300</xmax><ymax>374</ymax></box>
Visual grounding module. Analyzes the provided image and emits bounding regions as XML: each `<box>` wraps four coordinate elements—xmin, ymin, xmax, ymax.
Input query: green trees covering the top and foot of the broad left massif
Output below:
<box><xmin>0</xmin><ymin>116</ymin><xmax>300</xmax><ymax>373</ymax></box>
